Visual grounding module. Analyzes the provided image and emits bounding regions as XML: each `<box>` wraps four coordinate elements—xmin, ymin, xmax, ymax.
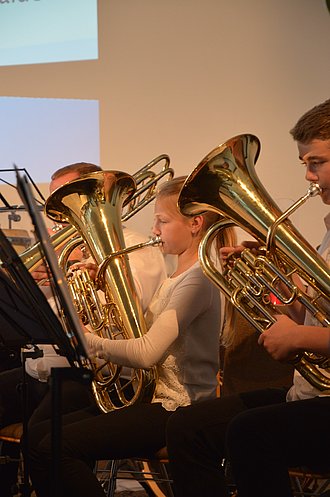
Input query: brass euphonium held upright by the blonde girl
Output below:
<box><xmin>45</xmin><ymin>171</ymin><xmax>159</xmax><ymax>412</ymax></box>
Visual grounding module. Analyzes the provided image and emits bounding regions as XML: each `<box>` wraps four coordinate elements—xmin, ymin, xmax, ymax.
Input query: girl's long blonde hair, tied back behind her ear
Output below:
<box><xmin>156</xmin><ymin>176</ymin><xmax>237</xmax><ymax>347</ymax></box>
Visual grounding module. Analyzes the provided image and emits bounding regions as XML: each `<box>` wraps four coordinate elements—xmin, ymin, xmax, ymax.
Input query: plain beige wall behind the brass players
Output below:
<box><xmin>0</xmin><ymin>0</ymin><xmax>330</xmax><ymax>248</ymax></box>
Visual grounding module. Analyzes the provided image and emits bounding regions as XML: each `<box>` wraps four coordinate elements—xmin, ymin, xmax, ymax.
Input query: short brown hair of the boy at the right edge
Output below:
<box><xmin>290</xmin><ymin>99</ymin><xmax>330</xmax><ymax>144</ymax></box>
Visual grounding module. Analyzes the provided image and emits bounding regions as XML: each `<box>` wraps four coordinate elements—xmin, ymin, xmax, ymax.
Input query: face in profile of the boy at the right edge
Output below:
<box><xmin>298</xmin><ymin>140</ymin><xmax>330</xmax><ymax>205</ymax></box>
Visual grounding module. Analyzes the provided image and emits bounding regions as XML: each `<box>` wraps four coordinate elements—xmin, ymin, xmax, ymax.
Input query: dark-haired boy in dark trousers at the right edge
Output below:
<box><xmin>167</xmin><ymin>100</ymin><xmax>330</xmax><ymax>497</ymax></box>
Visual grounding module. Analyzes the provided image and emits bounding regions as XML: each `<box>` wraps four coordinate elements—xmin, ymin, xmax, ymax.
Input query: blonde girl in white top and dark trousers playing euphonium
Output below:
<box><xmin>29</xmin><ymin>177</ymin><xmax>237</xmax><ymax>497</ymax></box>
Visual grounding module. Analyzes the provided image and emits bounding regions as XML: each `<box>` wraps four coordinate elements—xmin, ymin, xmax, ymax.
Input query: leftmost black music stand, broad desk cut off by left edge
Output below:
<box><xmin>0</xmin><ymin>229</ymin><xmax>73</xmax><ymax>496</ymax></box>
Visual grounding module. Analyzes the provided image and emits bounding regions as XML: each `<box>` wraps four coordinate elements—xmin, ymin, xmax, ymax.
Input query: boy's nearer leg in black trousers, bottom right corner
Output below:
<box><xmin>228</xmin><ymin>397</ymin><xmax>330</xmax><ymax>497</ymax></box>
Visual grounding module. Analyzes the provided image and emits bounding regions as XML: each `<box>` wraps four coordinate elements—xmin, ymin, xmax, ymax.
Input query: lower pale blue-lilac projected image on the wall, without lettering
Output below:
<box><xmin>0</xmin><ymin>97</ymin><xmax>100</xmax><ymax>199</ymax></box>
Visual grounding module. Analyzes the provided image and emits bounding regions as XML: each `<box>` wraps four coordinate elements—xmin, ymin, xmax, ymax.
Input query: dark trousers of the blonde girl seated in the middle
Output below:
<box><xmin>29</xmin><ymin>403</ymin><xmax>172</xmax><ymax>497</ymax></box>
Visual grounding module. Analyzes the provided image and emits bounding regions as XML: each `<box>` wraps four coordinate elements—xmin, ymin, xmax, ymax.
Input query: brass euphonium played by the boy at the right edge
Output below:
<box><xmin>178</xmin><ymin>134</ymin><xmax>330</xmax><ymax>390</ymax></box>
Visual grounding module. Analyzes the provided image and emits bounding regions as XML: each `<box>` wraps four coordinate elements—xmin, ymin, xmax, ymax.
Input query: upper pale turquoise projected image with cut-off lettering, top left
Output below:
<box><xmin>0</xmin><ymin>0</ymin><xmax>98</xmax><ymax>66</ymax></box>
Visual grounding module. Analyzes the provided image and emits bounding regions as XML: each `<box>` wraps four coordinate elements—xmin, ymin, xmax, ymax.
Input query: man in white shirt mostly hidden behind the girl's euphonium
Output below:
<box><xmin>0</xmin><ymin>162</ymin><xmax>166</xmax><ymax>497</ymax></box>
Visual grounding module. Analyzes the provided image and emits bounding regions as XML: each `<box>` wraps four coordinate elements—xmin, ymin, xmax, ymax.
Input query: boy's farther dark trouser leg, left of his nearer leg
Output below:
<box><xmin>167</xmin><ymin>389</ymin><xmax>286</xmax><ymax>497</ymax></box>
